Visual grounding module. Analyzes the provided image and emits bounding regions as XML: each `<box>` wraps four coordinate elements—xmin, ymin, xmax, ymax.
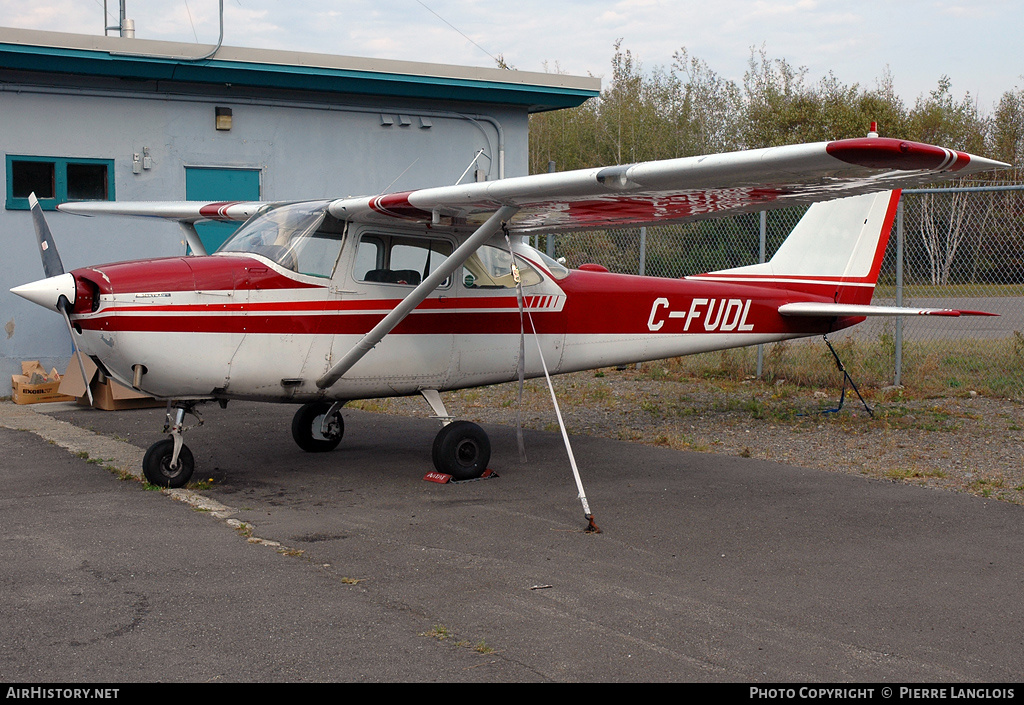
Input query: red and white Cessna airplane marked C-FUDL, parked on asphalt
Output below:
<box><xmin>12</xmin><ymin>135</ymin><xmax>1007</xmax><ymax>487</ymax></box>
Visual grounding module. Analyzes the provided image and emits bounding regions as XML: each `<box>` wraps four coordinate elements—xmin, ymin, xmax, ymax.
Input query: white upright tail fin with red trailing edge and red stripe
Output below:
<box><xmin>701</xmin><ymin>191</ymin><xmax>900</xmax><ymax>304</ymax></box>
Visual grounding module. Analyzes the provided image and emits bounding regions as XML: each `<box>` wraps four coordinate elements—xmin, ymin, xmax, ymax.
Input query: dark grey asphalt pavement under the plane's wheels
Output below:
<box><xmin>0</xmin><ymin>402</ymin><xmax>1024</xmax><ymax>683</ymax></box>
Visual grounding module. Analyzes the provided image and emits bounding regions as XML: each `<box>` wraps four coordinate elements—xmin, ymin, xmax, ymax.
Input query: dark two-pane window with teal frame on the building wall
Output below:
<box><xmin>6</xmin><ymin>155</ymin><xmax>114</xmax><ymax>210</ymax></box>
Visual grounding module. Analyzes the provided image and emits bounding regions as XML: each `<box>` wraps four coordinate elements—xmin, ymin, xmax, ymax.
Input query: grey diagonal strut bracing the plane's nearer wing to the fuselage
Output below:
<box><xmin>316</xmin><ymin>206</ymin><xmax>518</xmax><ymax>389</ymax></box>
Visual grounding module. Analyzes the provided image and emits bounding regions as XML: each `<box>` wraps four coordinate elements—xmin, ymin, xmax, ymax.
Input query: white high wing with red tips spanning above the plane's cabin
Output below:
<box><xmin>59</xmin><ymin>137</ymin><xmax>1010</xmax><ymax>234</ymax></box>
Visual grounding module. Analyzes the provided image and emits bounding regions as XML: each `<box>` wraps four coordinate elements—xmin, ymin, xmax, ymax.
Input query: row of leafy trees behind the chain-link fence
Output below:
<box><xmin>529</xmin><ymin>40</ymin><xmax>1024</xmax><ymax>284</ymax></box>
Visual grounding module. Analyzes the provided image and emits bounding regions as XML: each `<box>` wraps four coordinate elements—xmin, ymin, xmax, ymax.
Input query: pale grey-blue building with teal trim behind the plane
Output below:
<box><xmin>0</xmin><ymin>28</ymin><xmax>600</xmax><ymax>374</ymax></box>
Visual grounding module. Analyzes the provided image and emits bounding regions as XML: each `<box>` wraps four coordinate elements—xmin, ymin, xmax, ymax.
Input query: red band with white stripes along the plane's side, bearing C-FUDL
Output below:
<box><xmin>74</xmin><ymin>255</ymin><xmax>856</xmax><ymax>337</ymax></box>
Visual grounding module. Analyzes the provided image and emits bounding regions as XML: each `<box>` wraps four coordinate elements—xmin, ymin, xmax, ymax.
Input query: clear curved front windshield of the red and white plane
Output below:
<box><xmin>217</xmin><ymin>201</ymin><xmax>345</xmax><ymax>277</ymax></box>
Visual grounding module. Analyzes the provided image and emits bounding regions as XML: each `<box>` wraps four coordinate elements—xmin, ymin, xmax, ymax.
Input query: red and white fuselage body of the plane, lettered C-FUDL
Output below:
<box><xmin>61</xmin><ymin>229</ymin><xmax>857</xmax><ymax>403</ymax></box>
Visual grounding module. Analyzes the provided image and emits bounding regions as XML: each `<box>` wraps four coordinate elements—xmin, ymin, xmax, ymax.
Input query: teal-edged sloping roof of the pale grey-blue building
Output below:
<box><xmin>0</xmin><ymin>28</ymin><xmax>601</xmax><ymax>112</ymax></box>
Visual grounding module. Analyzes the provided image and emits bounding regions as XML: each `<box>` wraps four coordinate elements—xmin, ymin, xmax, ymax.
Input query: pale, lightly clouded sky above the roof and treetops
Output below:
<box><xmin>0</xmin><ymin>0</ymin><xmax>1024</xmax><ymax>113</ymax></box>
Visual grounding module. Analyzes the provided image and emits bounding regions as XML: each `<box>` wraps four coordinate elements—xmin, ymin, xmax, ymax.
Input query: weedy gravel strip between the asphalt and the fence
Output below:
<box><xmin>355</xmin><ymin>367</ymin><xmax>1024</xmax><ymax>504</ymax></box>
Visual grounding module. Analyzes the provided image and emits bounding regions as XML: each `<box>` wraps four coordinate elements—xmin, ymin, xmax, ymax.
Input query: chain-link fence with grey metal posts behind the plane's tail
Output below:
<box><xmin>535</xmin><ymin>184</ymin><xmax>1024</xmax><ymax>400</ymax></box>
